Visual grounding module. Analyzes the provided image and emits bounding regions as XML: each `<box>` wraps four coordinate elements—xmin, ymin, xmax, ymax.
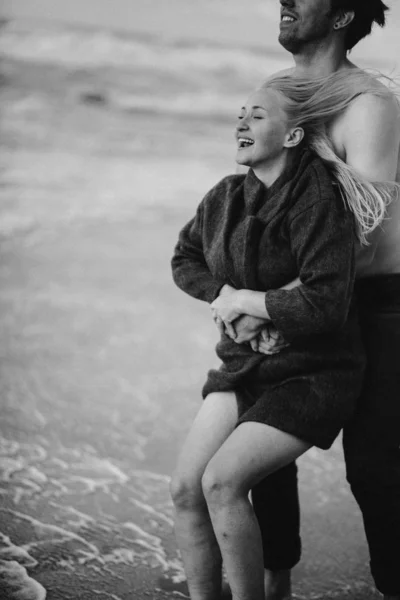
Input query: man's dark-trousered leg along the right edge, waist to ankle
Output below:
<box><xmin>343</xmin><ymin>275</ymin><xmax>400</xmax><ymax>600</ymax></box>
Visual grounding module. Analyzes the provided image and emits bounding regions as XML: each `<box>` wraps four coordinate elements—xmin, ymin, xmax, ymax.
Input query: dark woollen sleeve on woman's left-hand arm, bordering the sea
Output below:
<box><xmin>171</xmin><ymin>196</ymin><xmax>226</xmax><ymax>303</ymax></box>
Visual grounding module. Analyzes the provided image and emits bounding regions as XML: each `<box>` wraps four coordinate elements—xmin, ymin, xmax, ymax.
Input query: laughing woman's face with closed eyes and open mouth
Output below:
<box><xmin>236</xmin><ymin>89</ymin><xmax>289</xmax><ymax>169</ymax></box>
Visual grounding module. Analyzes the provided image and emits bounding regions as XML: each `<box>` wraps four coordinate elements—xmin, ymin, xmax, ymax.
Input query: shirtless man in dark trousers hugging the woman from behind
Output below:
<box><xmin>227</xmin><ymin>0</ymin><xmax>400</xmax><ymax>600</ymax></box>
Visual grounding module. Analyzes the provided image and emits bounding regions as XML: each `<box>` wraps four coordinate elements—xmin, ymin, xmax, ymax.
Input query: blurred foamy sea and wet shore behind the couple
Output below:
<box><xmin>0</xmin><ymin>22</ymin><xmax>394</xmax><ymax>600</ymax></box>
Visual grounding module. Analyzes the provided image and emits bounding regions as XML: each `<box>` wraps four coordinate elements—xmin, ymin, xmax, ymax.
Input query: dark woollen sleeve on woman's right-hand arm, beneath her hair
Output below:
<box><xmin>265</xmin><ymin>183</ymin><xmax>355</xmax><ymax>341</ymax></box>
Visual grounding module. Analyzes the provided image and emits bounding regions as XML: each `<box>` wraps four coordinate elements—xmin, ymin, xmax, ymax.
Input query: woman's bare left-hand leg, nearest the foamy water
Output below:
<box><xmin>171</xmin><ymin>393</ymin><xmax>238</xmax><ymax>600</ymax></box>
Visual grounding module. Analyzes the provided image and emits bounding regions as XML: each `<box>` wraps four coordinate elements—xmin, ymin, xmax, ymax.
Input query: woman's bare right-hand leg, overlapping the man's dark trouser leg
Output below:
<box><xmin>203</xmin><ymin>422</ymin><xmax>310</xmax><ymax>600</ymax></box>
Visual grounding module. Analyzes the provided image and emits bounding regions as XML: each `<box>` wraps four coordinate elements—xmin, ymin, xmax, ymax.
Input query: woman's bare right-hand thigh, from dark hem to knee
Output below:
<box><xmin>205</xmin><ymin>422</ymin><xmax>311</xmax><ymax>493</ymax></box>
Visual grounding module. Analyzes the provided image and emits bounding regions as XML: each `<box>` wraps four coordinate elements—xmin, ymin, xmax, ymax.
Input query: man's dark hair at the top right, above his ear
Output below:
<box><xmin>332</xmin><ymin>0</ymin><xmax>388</xmax><ymax>50</ymax></box>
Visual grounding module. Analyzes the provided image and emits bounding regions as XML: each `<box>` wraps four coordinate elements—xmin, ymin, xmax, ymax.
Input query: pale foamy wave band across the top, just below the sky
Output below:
<box><xmin>0</xmin><ymin>21</ymin><xmax>288</xmax><ymax>77</ymax></box>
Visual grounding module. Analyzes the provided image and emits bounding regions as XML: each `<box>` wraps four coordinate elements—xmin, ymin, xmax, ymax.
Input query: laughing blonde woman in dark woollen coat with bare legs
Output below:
<box><xmin>171</xmin><ymin>72</ymin><xmax>390</xmax><ymax>600</ymax></box>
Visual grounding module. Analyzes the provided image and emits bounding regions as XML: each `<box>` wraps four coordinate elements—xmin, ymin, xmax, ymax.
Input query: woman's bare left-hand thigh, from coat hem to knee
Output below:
<box><xmin>171</xmin><ymin>392</ymin><xmax>238</xmax><ymax>490</ymax></box>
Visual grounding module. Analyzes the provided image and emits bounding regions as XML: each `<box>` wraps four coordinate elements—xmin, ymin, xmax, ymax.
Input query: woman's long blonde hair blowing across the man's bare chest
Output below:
<box><xmin>261</xmin><ymin>69</ymin><xmax>400</xmax><ymax>245</ymax></box>
